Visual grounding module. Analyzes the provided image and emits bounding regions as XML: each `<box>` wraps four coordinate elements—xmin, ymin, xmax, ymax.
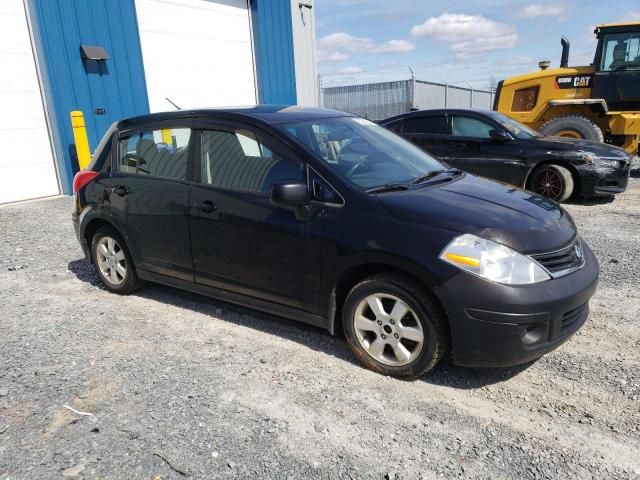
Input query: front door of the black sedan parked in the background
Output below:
<box><xmin>447</xmin><ymin>113</ymin><xmax>528</xmax><ymax>186</ymax></box>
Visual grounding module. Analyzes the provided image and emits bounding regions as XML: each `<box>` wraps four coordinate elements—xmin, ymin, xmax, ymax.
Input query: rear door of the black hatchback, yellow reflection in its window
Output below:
<box><xmin>105</xmin><ymin>124</ymin><xmax>193</xmax><ymax>281</ymax></box>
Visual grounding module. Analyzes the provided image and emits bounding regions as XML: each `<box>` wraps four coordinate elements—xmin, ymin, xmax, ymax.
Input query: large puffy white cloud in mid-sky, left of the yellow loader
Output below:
<box><xmin>411</xmin><ymin>13</ymin><xmax>518</xmax><ymax>60</ymax></box>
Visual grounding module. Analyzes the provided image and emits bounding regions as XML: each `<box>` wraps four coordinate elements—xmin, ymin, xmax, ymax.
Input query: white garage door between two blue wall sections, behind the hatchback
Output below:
<box><xmin>136</xmin><ymin>0</ymin><xmax>256</xmax><ymax>112</ymax></box>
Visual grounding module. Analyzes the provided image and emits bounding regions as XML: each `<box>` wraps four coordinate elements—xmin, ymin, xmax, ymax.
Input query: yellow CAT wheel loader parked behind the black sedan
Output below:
<box><xmin>494</xmin><ymin>22</ymin><xmax>640</xmax><ymax>154</ymax></box>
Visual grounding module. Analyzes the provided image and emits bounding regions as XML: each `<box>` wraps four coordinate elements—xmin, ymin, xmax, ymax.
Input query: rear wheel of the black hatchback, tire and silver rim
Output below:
<box><xmin>91</xmin><ymin>227</ymin><xmax>144</xmax><ymax>295</ymax></box>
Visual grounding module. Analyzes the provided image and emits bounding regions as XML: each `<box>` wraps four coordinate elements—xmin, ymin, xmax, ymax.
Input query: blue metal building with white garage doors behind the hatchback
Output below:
<box><xmin>0</xmin><ymin>0</ymin><xmax>317</xmax><ymax>203</ymax></box>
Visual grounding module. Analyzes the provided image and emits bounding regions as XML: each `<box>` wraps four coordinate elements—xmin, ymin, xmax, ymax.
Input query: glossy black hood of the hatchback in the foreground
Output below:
<box><xmin>378</xmin><ymin>174</ymin><xmax>577</xmax><ymax>253</ymax></box>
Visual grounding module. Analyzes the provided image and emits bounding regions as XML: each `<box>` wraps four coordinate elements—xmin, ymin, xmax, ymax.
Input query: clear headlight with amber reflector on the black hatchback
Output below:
<box><xmin>440</xmin><ymin>233</ymin><xmax>551</xmax><ymax>285</ymax></box>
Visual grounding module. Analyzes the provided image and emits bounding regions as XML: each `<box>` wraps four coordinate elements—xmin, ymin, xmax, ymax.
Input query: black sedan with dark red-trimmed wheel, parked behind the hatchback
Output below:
<box><xmin>380</xmin><ymin>109</ymin><xmax>631</xmax><ymax>202</ymax></box>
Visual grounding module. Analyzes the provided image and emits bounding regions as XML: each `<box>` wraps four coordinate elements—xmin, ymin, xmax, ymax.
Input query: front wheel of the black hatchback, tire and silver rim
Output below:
<box><xmin>342</xmin><ymin>274</ymin><xmax>449</xmax><ymax>378</ymax></box>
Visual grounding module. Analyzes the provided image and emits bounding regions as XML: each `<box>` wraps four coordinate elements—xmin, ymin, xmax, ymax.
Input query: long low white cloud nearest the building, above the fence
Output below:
<box><xmin>317</xmin><ymin>32</ymin><xmax>416</xmax><ymax>62</ymax></box>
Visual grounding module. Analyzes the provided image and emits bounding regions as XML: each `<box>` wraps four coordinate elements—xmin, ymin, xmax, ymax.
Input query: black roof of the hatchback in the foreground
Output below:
<box><xmin>117</xmin><ymin>105</ymin><xmax>354</xmax><ymax>130</ymax></box>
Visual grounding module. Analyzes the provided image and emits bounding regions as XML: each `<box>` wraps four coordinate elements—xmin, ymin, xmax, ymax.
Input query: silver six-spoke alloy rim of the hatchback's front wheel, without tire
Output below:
<box><xmin>353</xmin><ymin>293</ymin><xmax>425</xmax><ymax>367</ymax></box>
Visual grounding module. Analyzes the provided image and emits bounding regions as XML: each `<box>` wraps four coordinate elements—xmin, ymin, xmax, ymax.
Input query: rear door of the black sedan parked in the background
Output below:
<box><xmin>402</xmin><ymin>112</ymin><xmax>459</xmax><ymax>161</ymax></box>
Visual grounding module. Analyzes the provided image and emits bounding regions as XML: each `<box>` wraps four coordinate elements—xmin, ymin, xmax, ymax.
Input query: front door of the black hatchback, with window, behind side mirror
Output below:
<box><xmin>191</xmin><ymin>124</ymin><xmax>323</xmax><ymax>313</ymax></box>
